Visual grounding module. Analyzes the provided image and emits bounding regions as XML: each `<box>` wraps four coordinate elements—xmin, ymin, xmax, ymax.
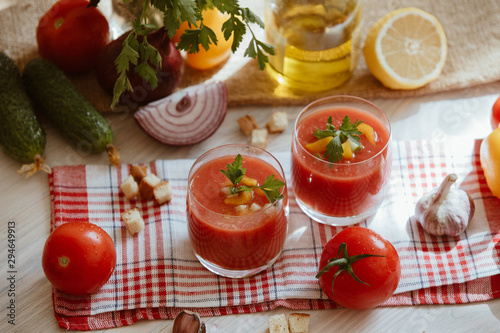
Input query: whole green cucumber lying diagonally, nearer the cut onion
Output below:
<box><xmin>22</xmin><ymin>58</ymin><xmax>119</xmax><ymax>165</ymax></box>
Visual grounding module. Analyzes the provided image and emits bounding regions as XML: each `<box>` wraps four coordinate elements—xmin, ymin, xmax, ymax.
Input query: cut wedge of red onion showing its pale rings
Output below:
<box><xmin>134</xmin><ymin>81</ymin><xmax>227</xmax><ymax>146</ymax></box>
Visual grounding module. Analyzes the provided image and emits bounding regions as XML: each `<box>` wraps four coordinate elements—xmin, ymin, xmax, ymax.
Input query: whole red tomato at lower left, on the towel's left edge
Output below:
<box><xmin>42</xmin><ymin>222</ymin><xmax>116</xmax><ymax>295</ymax></box>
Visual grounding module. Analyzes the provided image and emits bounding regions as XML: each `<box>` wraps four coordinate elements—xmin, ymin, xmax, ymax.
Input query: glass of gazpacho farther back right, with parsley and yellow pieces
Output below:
<box><xmin>291</xmin><ymin>96</ymin><xmax>392</xmax><ymax>226</ymax></box>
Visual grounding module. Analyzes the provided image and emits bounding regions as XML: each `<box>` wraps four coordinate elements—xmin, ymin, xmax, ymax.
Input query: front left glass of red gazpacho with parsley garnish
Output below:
<box><xmin>187</xmin><ymin>144</ymin><xmax>288</xmax><ymax>278</ymax></box>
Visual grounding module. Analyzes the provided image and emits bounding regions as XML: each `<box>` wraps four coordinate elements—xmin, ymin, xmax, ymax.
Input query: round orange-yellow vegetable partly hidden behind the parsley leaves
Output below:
<box><xmin>172</xmin><ymin>8</ymin><xmax>233</xmax><ymax>70</ymax></box>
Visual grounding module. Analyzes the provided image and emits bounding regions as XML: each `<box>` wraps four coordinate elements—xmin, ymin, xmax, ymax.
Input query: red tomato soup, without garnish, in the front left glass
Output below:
<box><xmin>187</xmin><ymin>155</ymin><xmax>288</xmax><ymax>270</ymax></box>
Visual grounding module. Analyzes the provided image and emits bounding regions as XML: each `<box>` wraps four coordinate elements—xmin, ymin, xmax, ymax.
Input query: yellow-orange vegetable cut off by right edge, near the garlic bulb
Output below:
<box><xmin>479</xmin><ymin>127</ymin><xmax>500</xmax><ymax>199</ymax></box>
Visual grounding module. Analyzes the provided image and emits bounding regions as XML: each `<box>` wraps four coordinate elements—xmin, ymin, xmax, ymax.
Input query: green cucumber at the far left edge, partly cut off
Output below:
<box><xmin>0</xmin><ymin>52</ymin><xmax>50</xmax><ymax>177</ymax></box>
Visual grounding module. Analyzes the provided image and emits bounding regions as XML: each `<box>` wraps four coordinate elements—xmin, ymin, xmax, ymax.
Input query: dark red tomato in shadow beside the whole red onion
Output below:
<box><xmin>36</xmin><ymin>0</ymin><xmax>110</xmax><ymax>74</ymax></box>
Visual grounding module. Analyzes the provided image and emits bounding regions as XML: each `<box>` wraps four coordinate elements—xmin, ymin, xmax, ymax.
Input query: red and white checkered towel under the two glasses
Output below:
<box><xmin>49</xmin><ymin>141</ymin><xmax>500</xmax><ymax>330</ymax></box>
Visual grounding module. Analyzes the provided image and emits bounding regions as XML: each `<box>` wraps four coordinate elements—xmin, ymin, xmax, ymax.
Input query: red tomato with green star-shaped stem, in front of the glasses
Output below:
<box><xmin>316</xmin><ymin>227</ymin><xmax>401</xmax><ymax>309</ymax></box>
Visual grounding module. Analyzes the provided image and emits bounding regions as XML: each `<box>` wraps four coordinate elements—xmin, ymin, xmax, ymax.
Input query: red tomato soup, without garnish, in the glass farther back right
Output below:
<box><xmin>291</xmin><ymin>107</ymin><xmax>391</xmax><ymax>217</ymax></box>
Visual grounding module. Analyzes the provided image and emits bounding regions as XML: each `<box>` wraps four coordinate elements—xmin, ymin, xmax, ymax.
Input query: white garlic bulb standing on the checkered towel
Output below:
<box><xmin>415</xmin><ymin>173</ymin><xmax>476</xmax><ymax>236</ymax></box>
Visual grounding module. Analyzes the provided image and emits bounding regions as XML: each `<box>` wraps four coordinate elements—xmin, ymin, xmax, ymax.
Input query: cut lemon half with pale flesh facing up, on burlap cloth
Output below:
<box><xmin>363</xmin><ymin>8</ymin><xmax>448</xmax><ymax>89</ymax></box>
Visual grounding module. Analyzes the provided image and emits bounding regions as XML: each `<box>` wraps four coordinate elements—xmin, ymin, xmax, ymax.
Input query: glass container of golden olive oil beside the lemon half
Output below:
<box><xmin>266</xmin><ymin>0</ymin><xmax>361</xmax><ymax>92</ymax></box>
